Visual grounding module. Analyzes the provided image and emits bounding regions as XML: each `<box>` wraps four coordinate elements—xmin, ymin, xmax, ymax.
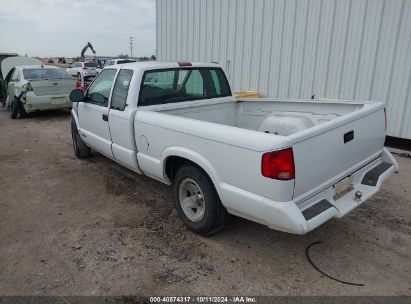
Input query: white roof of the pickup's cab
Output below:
<box><xmin>107</xmin><ymin>61</ymin><xmax>220</xmax><ymax>71</ymax></box>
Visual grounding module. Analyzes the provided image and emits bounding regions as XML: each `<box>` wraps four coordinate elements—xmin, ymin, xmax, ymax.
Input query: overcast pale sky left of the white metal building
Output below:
<box><xmin>0</xmin><ymin>0</ymin><xmax>156</xmax><ymax>57</ymax></box>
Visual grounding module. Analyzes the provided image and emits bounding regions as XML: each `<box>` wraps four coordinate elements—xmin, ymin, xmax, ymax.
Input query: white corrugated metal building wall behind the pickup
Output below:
<box><xmin>157</xmin><ymin>0</ymin><xmax>411</xmax><ymax>139</ymax></box>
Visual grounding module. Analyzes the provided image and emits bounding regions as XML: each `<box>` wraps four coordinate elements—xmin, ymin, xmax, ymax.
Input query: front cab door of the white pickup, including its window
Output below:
<box><xmin>78</xmin><ymin>69</ymin><xmax>117</xmax><ymax>158</ymax></box>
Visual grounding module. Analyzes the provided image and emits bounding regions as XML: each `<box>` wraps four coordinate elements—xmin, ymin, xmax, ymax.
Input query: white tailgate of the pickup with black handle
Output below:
<box><xmin>293</xmin><ymin>103</ymin><xmax>385</xmax><ymax>202</ymax></box>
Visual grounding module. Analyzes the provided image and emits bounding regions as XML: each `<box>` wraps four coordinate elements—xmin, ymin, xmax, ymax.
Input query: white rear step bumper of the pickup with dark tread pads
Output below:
<box><xmin>222</xmin><ymin>148</ymin><xmax>398</xmax><ymax>234</ymax></box>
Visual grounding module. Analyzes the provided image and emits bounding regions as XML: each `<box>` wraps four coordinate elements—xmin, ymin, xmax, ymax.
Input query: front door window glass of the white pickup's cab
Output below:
<box><xmin>86</xmin><ymin>69</ymin><xmax>117</xmax><ymax>107</ymax></box>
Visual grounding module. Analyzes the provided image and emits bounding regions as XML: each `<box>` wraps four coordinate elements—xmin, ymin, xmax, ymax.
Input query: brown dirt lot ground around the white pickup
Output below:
<box><xmin>0</xmin><ymin>111</ymin><xmax>411</xmax><ymax>295</ymax></box>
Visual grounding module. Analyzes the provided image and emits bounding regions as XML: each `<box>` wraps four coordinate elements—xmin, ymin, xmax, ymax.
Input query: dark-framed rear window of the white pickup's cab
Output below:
<box><xmin>138</xmin><ymin>67</ymin><xmax>231</xmax><ymax>106</ymax></box>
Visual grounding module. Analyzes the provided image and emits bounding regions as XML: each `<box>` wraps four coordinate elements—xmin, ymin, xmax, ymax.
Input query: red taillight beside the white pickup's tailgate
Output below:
<box><xmin>261</xmin><ymin>148</ymin><xmax>295</xmax><ymax>180</ymax></box>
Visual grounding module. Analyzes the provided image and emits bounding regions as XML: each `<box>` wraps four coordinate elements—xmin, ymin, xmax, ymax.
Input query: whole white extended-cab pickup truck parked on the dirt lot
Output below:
<box><xmin>70</xmin><ymin>62</ymin><xmax>398</xmax><ymax>235</ymax></box>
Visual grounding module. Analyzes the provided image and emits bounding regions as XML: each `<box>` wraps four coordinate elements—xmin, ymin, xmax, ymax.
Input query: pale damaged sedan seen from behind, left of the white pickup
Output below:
<box><xmin>5</xmin><ymin>65</ymin><xmax>76</xmax><ymax>119</ymax></box>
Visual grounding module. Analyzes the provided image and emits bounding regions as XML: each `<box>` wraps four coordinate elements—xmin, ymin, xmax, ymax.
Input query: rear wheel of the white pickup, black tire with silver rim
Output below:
<box><xmin>174</xmin><ymin>165</ymin><xmax>229</xmax><ymax>235</ymax></box>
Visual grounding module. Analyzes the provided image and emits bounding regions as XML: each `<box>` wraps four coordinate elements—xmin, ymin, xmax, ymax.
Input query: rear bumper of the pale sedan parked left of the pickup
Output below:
<box><xmin>22</xmin><ymin>92</ymin><xmax>72</xmax><ymax>113</ymax></box>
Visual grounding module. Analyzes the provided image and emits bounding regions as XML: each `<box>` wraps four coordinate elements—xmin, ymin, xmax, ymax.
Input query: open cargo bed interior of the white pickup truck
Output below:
<box><xmin>158</xmin><ymin>99</ymin><xmax>364</xmax><ymax>136</ymax></box>
